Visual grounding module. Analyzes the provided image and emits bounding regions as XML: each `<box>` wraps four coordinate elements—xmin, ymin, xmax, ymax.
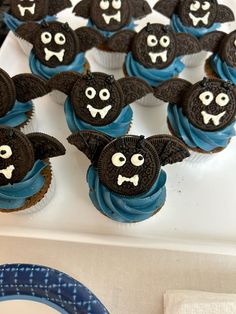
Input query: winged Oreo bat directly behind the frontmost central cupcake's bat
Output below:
<box><xmin>48</xmin><ymin>72</ymin><xmax>152</xmax><ymax>126</ymax></box>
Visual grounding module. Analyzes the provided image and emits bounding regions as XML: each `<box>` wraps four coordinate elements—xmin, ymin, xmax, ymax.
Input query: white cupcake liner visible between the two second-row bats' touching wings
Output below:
<box><xmin>93</xmin><ymin>48</ymin><xmax>126</xmax><ymax>70</ymax></box>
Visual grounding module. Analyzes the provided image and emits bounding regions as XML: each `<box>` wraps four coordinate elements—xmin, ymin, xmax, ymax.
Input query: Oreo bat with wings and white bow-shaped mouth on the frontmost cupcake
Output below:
<box><xmin>68</xmin><ymin>131</ymin><xmax>189</xmax><ymax>196</ymax></box>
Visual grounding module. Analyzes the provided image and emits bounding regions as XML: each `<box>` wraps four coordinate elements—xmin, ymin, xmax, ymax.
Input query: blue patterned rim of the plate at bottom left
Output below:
<box><xmin>0</xmin><ymin>264</ymin><xmax>108</xmax><ymax>314</ymax></box>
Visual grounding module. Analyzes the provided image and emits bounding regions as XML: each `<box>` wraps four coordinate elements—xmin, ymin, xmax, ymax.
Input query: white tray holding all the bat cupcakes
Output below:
<box><xmin>0</xmin><ymin>1</ymin><xmax>236</xmax><ymax>255</ymax></box>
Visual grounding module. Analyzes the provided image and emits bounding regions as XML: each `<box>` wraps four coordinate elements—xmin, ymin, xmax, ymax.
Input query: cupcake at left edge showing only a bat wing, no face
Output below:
<box><xmin>0</xmin><ymin>69</ymin><xmax>50</xmax><ymax>133</ymax></box>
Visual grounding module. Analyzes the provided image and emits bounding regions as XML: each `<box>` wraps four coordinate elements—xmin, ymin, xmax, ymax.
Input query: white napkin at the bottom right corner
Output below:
<box><xmin>164</xmin><ymin>290</ymin><xmax>236</xmax><ymax>314</ymax></box>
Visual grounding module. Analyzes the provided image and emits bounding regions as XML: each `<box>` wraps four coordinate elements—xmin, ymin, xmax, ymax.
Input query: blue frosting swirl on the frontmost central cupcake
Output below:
<box><xmin>87</xmin><ymin>166</ymin><xmax>166</xmax><ymax>222</ymax></box>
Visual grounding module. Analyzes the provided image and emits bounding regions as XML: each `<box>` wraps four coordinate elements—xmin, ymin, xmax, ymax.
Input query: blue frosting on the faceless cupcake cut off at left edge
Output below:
<box><xmin>0</xmin><ymin>101</ymin><xmax>33</xmax><ymax>128</ymax></box>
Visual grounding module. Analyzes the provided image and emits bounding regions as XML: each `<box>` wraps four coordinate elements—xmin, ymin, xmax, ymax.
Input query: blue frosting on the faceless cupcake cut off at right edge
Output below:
<box><xmin>210</xmin><ymin>54</ymin><xmax>236</xmax><ymax>84</ymax></box>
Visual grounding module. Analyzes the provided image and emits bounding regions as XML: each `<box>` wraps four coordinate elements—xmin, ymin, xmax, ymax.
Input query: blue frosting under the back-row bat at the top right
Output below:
<box><xmin>170</xmin><ymin>14</ymin><xmax>220</xmax><ymax>37</ymax></box>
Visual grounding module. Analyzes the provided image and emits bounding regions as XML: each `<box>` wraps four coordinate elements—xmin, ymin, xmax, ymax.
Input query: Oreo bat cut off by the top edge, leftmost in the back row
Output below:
<box><xmin>10</xmin><ymin>0</ymin><xmax>72</xmax><ymax>22</ymax></box>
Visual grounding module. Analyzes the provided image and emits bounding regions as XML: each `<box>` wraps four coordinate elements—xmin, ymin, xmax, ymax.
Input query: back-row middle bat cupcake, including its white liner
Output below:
<box><xmin>73</xmin><ymin>0</ymin><xmax>152</xmax><ymax>69</ymax></box>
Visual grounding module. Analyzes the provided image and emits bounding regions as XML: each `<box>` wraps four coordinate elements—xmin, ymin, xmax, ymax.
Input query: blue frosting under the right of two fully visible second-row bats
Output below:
<box><xmin>125</xmin><ymin>52</ymin><xmax>185</xmax><ymax>86</ymax></box>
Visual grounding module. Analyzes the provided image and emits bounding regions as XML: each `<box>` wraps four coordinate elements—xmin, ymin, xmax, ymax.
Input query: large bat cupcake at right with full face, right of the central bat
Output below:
<box><xmin>154</xmin><ymin>78</ymin><xmax>236</xmax><ymax>160</ymax></box>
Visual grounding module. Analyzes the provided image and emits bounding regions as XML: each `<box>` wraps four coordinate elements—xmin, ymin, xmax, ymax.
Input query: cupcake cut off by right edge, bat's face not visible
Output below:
<box><xmin>201</xmin><ymin>31</ymin><xmax>236</xmax><ymax>84</ymax></box>
